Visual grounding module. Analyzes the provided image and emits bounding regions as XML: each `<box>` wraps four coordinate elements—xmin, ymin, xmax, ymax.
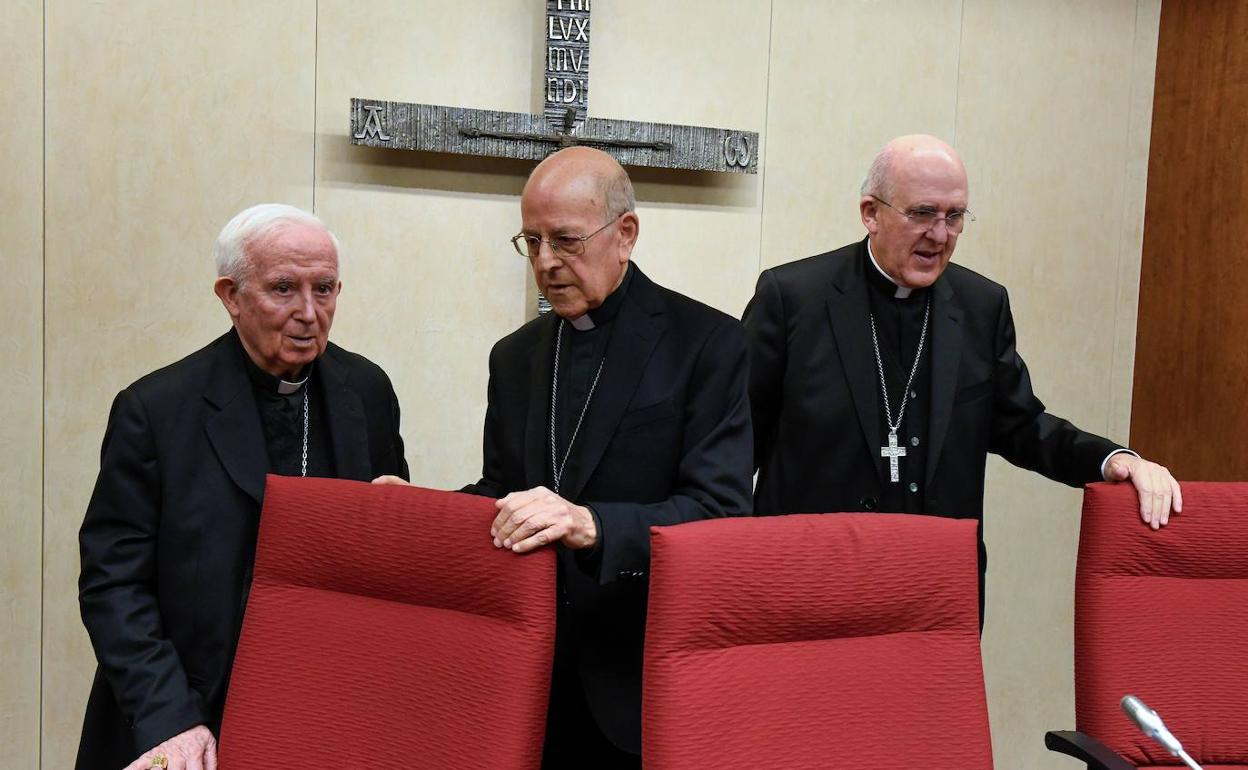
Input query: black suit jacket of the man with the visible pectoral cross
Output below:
<box><xmin>744</xmin><ymin>240</ymin><xmax>1121</xmax><ymax>551</ymax></box>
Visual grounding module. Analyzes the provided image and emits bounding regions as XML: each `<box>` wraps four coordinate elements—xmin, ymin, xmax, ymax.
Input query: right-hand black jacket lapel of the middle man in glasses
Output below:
<box><xmin>564</xmin><ymin>266</ymin><xmax>665</xmax><ymax>500</ymax></box>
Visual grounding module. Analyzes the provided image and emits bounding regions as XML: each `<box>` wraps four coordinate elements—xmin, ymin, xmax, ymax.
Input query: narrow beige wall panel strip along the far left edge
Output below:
<box><xmin>0</xmin><ymin>0</ymin><xmax>44</xmax><ymax>768</ymax></box>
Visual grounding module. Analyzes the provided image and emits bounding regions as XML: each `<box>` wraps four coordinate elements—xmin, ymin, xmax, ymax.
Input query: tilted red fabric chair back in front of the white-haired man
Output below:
<box><xmin>221</xmin><ymin>475</ymin><xmax>554</xmax><ymax>770</ymax></box>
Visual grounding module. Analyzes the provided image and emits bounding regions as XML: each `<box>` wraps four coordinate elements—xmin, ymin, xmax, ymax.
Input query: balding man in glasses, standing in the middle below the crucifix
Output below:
<box><xmin>378</xmin><ymin>147</ymin><xmax>753</xmax><ymax>770</ymax></box>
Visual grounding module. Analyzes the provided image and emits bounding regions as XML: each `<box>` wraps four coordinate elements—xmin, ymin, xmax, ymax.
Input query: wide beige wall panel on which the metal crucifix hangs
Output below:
<box><xmin>317</xmin><ymin>0</ymin><xmax>769</xmax><ymax>487</ymax></box>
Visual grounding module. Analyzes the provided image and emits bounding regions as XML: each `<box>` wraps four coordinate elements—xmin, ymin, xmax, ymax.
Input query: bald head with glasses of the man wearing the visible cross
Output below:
<box><xmin>859</xmin><ymin>134</ymin><xmax>968</xmax><ymax>288</ymax></box>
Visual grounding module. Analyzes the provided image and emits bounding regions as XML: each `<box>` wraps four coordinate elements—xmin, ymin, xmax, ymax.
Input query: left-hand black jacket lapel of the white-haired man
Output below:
<box><xmin>203</xmin><ymin>331</ymin><xmax>268</xmax><ymax>503</ymax></box>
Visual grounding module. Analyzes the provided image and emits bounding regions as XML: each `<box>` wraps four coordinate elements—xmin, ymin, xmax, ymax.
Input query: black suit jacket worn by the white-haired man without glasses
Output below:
<box><xmin>77</xmin><ymin>331</ymin><xmax>407</xmax><ymax>770</ymax></box>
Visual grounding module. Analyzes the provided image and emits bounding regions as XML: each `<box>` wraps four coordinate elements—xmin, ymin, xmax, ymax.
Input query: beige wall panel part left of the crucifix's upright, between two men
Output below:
<box><xmin>316</xmin><ymin>0</ymin><xmax>534</xmax><ymax>487</ymax></box>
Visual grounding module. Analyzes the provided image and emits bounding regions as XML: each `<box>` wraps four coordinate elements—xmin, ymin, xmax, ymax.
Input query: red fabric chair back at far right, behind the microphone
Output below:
<box><xmin>1075</xmin><ymin>483</ymin><xmax>1248</xmax><ymax>769</ymax></box>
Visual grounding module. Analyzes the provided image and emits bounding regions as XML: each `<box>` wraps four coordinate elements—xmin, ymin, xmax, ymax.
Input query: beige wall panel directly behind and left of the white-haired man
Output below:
<box><xmin>44</xmin><ymin>0</ymin><xmax>316</xmax><ymax>768</ymax></box>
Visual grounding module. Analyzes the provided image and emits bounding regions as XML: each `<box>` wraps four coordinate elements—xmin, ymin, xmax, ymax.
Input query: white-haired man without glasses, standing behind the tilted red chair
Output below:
<box><xmin>77</xmin><ymin>203</ymin><xmax>407</xmax><ymax>770</ymax></box>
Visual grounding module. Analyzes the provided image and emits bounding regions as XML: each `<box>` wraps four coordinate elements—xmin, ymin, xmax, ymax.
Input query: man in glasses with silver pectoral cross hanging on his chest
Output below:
<box><xmin>744</xmin><ymin>136</ymin><xmax>1183</xmax><ymax>621</ymax></box>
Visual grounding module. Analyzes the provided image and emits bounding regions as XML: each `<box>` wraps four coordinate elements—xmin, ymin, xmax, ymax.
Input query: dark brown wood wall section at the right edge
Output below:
<box><xmin>1131</xmin><ymin>0</ymin><xmax>1248</xmax><ymax>480</ymax></box>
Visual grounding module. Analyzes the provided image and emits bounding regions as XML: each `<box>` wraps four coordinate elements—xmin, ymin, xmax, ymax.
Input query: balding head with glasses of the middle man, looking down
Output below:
<box><xmin>520</xmin><ymin>147</ymin><xmax>640</xmax><ymax>321</ymax></box>
